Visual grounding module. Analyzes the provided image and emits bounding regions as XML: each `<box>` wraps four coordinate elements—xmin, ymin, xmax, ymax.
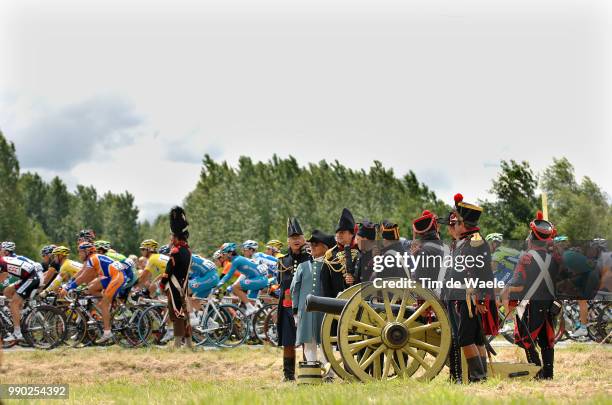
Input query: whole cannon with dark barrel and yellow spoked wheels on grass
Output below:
<box><xmin>306</xmin><ymin>282</ymin><xmax>539</xmax><ymax>382</ymax></box>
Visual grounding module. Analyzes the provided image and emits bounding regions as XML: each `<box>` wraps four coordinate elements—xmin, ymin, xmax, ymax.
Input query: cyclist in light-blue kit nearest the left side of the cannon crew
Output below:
<box><xmin>217</xmin><ymin>243</ymin><xmax>268</xmax><ymax>316</ymax></box>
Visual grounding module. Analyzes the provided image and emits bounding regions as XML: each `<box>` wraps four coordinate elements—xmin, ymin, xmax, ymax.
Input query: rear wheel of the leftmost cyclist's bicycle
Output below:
<box><xmin>24</xmin><ymin>305</ymin><xmax>67</xmax><ymax>350</ymax></box>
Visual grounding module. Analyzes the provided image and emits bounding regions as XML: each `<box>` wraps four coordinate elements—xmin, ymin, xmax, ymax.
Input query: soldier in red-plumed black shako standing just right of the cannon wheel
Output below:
<box><xmin>448</xmin><ymin>194</ymin><xmax>498</xmax><ymax>382</ymax></box>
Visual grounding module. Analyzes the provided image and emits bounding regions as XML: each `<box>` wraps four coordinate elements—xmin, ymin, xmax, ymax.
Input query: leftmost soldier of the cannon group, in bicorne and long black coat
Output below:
<box><xmin>277</xmin><ymin>218</ymin><xmax>311</xmax><ymax>381</ymax></box>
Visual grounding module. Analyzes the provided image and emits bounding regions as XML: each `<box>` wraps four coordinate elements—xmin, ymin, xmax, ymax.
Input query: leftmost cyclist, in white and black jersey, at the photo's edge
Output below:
<box><xmin>0</xmin><ymin>241</ymin><xmax>42</xmax><ymax>342</ymax></box>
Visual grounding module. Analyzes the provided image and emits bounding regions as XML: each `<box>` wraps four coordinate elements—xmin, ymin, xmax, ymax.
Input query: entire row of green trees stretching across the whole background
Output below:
<box><xmin>0</xmin><ymin>132</ymin><xmax>612</xmax><ymax>255</ymax></box>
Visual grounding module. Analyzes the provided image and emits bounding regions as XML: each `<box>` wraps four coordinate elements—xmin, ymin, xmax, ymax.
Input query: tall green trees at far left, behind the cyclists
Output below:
<box><xmin>0</xmin><ymin>132</ymin><xmax>140</xmax><ymax>258</ymax></box>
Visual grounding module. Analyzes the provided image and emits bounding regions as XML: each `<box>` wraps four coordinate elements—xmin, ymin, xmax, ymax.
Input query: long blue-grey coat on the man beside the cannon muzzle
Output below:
<box><xmin>291</xmin><ymin>260</ymin><xmax>323</xmax><ymax>345</ymax></box>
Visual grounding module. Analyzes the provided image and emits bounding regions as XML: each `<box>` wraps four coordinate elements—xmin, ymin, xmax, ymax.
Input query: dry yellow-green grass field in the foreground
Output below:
<box><xmin>0</xmin><ymin>345</ymin><xmax>612</xmax><ymax>405</ymax></box>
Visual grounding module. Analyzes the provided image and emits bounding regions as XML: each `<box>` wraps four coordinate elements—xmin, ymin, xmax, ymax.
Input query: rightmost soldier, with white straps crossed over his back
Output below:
<box><xmin>502</xmin><ymin>212</ymin><xmax>561</xmax><ymax>379</ymax></box>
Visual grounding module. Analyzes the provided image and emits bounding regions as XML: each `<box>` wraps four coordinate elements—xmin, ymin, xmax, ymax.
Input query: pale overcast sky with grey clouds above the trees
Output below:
<box><xmin>0</xmin><ymin>0</ymin><xmax>612</xmax><ymax>219</ymax></box>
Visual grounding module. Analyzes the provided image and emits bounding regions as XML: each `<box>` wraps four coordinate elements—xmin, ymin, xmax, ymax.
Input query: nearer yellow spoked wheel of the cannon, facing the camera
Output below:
<box><xmin>338</xmin><ymin>279</ymin><xmax>451</xmax><ymax>382</ymax></box>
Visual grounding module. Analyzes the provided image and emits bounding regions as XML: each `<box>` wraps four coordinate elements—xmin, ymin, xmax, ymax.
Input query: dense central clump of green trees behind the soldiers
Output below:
<box><xmin>185</xmin><ymin>156</ymin><xmax>449</xmax><ymax>254</ymax></box>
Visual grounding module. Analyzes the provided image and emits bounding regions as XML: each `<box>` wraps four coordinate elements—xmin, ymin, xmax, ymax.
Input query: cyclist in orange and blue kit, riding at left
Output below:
<box><xmin>64</xmin><ymin>242</ymin><xmax>126</xmax><ymax>343</ymax></box>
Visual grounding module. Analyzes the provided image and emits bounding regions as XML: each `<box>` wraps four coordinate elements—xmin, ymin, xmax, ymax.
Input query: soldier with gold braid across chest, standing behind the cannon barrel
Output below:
<box><xmin>321</xmin><ymin>208</ymin><xmax>359</xmax><ymax>298</ymax></box>
